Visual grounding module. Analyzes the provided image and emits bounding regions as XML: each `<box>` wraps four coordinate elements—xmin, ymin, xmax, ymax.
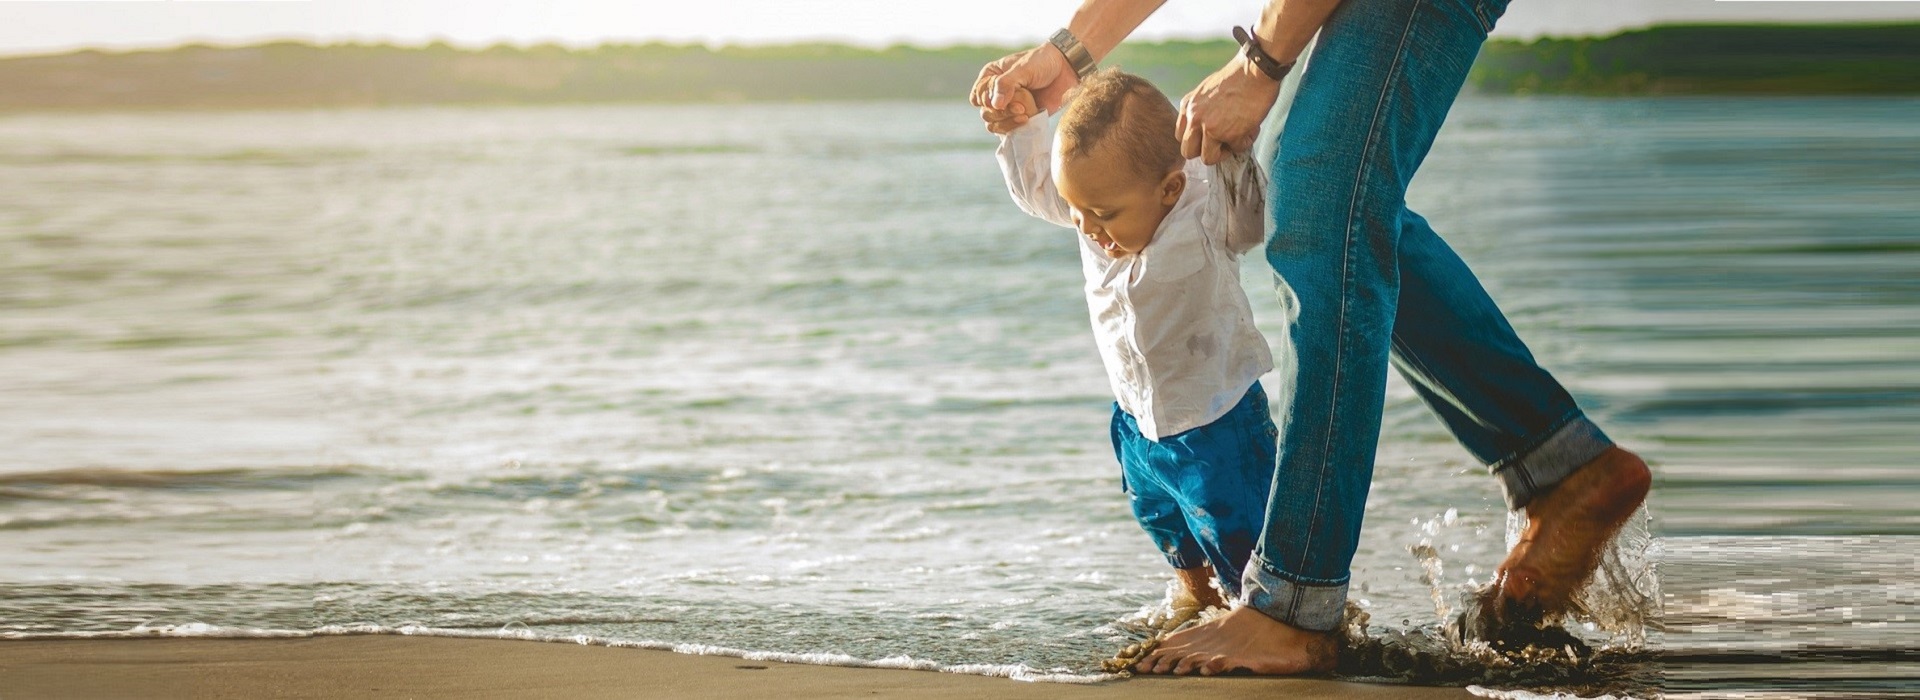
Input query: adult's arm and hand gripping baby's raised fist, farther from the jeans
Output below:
<box><xmin>968</xmin><ymin>0</ymin><xmax>1165</xmax><ymax>127</ymax></box>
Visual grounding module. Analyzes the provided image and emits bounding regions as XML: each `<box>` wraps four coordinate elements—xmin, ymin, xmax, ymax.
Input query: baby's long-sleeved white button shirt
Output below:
<box><xmin>995</xmin><ymin>119</ymin><xmax>1273</xmax><ymax>441</ymax></box>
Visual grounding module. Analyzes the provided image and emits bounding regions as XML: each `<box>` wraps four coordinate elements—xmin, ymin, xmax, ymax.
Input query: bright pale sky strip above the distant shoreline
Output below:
<box><xmin>0</xmin><ymin>0</ymin><xmax>1920</xmax><ymax>54</ymax></box>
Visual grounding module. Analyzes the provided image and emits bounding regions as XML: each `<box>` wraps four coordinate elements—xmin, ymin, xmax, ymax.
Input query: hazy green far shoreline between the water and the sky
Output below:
<box><xmin>0</xmin><ymin>25</ymin><xmax>1920</xmax><ymax>109</ymax></box>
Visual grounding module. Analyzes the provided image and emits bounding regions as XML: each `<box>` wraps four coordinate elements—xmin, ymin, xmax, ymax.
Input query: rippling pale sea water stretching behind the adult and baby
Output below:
<box><xmin>0</xmin><ymin>96</ymin><xmax>1920</xmax><ymax>696</ymax></box>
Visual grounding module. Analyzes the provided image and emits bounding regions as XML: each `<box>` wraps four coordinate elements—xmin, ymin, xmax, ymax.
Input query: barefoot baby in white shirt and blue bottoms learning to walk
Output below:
<box><xmin>983</xmin><ymin>69</ymin><xmax>1279</xmax><ymax>608</ymax></box>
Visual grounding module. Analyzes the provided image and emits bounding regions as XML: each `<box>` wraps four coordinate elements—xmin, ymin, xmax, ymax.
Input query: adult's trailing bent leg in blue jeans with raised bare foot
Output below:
<box><xmin>1392</xmin><ymin>211</ymin><xmax>1651</xmax><ymax>637</ymax></box>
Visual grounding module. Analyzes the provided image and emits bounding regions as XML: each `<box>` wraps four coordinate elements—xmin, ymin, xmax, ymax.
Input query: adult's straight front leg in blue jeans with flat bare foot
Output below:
<box><xmin>1137</xmin><ymin>0</ymin><xmax>1528</xmax><ymax>673</ymax></box>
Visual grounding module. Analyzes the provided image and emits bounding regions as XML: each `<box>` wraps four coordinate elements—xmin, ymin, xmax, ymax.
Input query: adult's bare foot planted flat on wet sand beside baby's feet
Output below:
<box><xmin>1133</xmin><ymin>608</ymin><xmax>1340</xmax><ymax>675</ymax></box>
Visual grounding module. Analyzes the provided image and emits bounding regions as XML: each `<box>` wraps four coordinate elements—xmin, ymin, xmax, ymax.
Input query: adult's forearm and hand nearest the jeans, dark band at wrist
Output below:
<box><xmin>1177</xmin><ymin>0</ymin><xmax>1340</xmax><ymax>165</ymax></box>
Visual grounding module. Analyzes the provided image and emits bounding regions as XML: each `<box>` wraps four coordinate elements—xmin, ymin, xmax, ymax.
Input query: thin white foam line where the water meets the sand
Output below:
<box><xmin>0</xmin><ymin>621</ymin><xmax>1117</xmax><ymax>683</ymax></box>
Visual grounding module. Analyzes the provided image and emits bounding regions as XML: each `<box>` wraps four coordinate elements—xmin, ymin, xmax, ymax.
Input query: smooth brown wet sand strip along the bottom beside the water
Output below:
<box><xmin>0</xmin><ymin>635</ymin><xmax>1471</xmax><ymax>700</ymax></box>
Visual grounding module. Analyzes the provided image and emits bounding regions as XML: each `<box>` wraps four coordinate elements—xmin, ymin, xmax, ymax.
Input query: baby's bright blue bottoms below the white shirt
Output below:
<box><xmin>1112</xmin><ymin>382</ymin><xmax>1281</xmax><ymax>596</ymax></box>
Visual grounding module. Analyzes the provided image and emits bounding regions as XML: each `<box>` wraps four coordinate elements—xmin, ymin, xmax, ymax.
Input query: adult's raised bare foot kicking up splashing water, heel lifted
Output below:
<box><xmin>1490</xmin><ymin>447</ymin><xmax>1653</xmax><ymax>621</ymax></box>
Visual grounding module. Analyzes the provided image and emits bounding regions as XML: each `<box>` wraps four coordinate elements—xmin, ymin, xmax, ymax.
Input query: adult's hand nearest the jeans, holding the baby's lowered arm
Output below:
<box><xmin>1175</xmin><ymin>56</ymin><xmax>1281</xmax><ymax>165</ymax></box>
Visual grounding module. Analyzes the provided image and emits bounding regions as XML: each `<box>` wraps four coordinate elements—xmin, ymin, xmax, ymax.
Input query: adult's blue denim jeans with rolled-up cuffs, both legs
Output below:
<box><xmin>1242</xmin><ymin>0</ymin><xmax>1613</xmax><ymax>631</ymax></box>
